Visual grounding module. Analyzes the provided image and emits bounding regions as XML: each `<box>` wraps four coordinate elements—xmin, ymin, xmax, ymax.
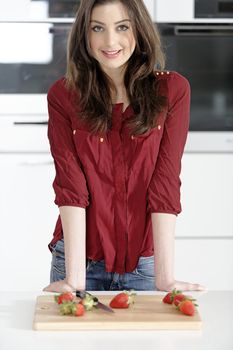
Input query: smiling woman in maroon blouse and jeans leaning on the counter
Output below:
<box><xmin>44</xmin><ymin>0</ymin><xmax>204</xmax><ymax>292</ymax></box>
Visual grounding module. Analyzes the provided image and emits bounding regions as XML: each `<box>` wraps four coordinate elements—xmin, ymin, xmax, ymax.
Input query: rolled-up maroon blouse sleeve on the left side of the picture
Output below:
<box><xmin>47</xmin><ymin>82</ymin><xmax>89</xmax><ymax>208</ymax></box>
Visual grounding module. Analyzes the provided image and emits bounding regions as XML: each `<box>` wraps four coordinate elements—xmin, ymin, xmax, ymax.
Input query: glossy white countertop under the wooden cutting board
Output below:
<box><xmin>0</xmin><ymin>291</ymin><xmax>233</xmax><ymax>350</ymax></box>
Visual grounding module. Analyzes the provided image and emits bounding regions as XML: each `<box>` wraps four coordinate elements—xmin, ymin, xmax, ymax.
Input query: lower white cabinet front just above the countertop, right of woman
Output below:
<box><xmin>175</xmin><ymin>238</ymin><xmax>233</xmax><ymax>290</ymax></box>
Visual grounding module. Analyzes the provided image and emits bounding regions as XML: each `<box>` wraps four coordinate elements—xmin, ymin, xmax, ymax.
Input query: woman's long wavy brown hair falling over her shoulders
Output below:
<box><xmin>66</xmin><ymin>0</ymin><xmax>167</xmax><ymax>135</ymax></box>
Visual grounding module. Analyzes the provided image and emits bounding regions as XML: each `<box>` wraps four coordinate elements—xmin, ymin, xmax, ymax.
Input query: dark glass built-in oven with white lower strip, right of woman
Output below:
<box><xmin>158</xmin><ymin>23</ymin><xmax>233</xmax><ymax>152</ymax></box>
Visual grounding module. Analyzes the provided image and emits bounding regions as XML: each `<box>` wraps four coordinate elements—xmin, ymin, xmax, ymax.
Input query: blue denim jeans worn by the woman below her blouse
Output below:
<box><xmin>50</xmin><ymin>239</ymin><xmax>156</xmax><ymax>291</ymax></box>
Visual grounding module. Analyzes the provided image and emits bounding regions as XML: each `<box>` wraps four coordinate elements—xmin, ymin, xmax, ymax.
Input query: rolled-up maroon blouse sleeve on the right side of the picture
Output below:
<box><xmin>147</xmin><ymin>72</ymin><xmax>190</xmax><ymax>215</ymax></box>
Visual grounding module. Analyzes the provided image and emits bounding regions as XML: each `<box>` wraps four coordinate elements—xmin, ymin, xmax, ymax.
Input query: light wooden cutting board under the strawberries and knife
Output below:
<box><xmin>33</xmin><ymin>295</ymin><xmax>202</xmax><ymax>331</ymax></box>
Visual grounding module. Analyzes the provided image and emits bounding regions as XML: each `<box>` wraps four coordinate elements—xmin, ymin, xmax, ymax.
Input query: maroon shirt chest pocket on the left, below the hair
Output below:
<box><xmin>73</xmin><ymin>129</ymin><xmax>111</xmax><ymax>172</ymax></box>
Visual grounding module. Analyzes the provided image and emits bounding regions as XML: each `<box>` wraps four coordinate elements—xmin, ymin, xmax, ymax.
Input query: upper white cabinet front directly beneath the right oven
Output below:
<box><xmin>176</xmin><ymin>153</ymin><xmax>233</xmax><ymax>238</ymax></box>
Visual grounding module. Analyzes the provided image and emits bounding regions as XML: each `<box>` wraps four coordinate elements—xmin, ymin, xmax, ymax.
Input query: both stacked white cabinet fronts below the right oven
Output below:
<box><xmin>175</xmin><ymin>153</ymin><xmax>233</xmax><ymax>290</ymax></box>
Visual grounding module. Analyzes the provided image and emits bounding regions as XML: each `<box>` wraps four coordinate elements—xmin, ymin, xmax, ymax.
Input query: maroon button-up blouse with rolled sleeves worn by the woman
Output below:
<box><xmin>48</xmin><ymin>71</ymin><xmax>190</xmax><ymax>273</ymax></box>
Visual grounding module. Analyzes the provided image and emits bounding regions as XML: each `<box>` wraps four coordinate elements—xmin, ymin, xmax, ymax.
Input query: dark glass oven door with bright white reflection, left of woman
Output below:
<box><xmin>0</xmin><ymin>22</ymin><xmax>71</xmax><ymax>95</ymax></box>
